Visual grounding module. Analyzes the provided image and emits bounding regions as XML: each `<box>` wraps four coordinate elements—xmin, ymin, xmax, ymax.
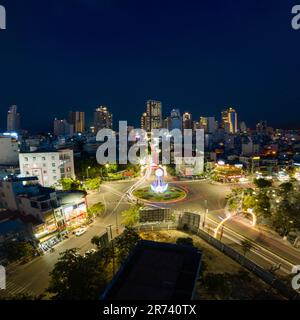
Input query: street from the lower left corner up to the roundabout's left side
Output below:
<box><xmin>0</xmin><ymin>181</ymin><xmax>133</xmax><ymax>297</ymax></box>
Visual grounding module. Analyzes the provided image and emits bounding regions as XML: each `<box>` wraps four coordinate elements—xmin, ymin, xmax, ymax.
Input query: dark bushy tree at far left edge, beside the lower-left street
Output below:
<box><xmin>4</xmin><ymin>241</ymin><xmax>34</xmax><ymax>261</ymax></box>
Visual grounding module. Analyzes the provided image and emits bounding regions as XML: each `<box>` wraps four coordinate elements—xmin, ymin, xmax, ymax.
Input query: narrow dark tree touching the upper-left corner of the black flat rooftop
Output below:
<box><xmin>114</xmin><ymin>227</ymin><xmax>141</xmax><ymax>264</ymax></box>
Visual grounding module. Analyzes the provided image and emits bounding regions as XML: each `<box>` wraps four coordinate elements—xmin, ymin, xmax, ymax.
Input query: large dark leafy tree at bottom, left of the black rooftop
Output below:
<box><xmin>47</xmin><ymin>248</ymin><xmax>111</xmax><ymax>300</ymax></box>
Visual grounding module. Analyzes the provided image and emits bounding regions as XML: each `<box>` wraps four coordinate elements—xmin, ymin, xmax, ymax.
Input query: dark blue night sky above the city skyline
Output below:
<box><xmin>0</xmin><ymin>0</ymin><xmax>300</xmax><ymax>132</ymax></box>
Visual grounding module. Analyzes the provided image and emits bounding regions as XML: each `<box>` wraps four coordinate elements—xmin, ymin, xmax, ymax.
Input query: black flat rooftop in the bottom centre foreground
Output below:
<box><xmin>102</xmin><ymin>240</ymin><xmax>202</xmax><ymax>300</ymax></box>
